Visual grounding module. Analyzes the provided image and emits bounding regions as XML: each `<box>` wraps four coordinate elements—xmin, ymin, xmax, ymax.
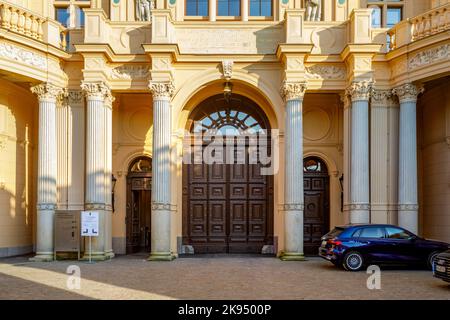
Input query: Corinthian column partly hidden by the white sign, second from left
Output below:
<box><xmin>81</xmin><ymin>82</ymin><xmax>114</xmax><ymax>260</ymax></box>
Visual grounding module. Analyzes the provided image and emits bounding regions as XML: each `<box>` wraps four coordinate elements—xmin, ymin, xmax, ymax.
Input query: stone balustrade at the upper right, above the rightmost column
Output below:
<box><xmin>387</xmin><ymin>3</ymin><xmax>450</xmax><ymax>50</ymax></box>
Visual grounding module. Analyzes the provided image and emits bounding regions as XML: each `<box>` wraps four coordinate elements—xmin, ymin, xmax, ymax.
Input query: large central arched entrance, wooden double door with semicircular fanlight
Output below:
<box><xmin>183</xmin><ymin>95</ymin><xmax>273</xmax><ymax>253</ymax></box>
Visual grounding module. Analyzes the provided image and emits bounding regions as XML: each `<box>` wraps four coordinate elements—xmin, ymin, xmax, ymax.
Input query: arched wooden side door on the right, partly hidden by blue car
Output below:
<box><xmin>303</xmin><ymin>157</ymin><xmax>330</xmax><ymax>255</ymax></box>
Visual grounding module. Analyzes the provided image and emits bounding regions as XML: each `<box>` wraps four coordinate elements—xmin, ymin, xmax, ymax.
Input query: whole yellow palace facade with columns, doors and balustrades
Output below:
<box><xmin>0</xmin><ymin>0</ymin><xmax>450</xmax><ymax>261</ymax></box>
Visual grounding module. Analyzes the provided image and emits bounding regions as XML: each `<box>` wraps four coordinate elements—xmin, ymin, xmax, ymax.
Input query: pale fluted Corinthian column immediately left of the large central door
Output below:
<box><xmin>148</xmin><ymin>82</ymin><xmax>175</xmax><ymax>261</ymax></box>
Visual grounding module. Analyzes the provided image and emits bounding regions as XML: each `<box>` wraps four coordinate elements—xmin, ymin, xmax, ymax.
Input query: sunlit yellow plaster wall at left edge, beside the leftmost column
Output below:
<box><xmin>0</xmin><ymin>80</ymin><xmax>37</xmax><ymax>257</ymax></box>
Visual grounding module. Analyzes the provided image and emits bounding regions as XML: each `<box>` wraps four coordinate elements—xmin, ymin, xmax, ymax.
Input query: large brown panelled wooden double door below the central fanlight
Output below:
<box><xmin>183</xmin><ymin>146</ymin><xmax>273</xmax><ymax>253</ymax></box>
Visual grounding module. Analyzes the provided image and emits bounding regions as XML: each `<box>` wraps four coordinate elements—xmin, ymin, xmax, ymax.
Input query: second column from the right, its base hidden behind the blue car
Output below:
<box><xmin>347</xmin><ymin>81</ymin><xmax>372</xmax><ymax>223</ymax></box>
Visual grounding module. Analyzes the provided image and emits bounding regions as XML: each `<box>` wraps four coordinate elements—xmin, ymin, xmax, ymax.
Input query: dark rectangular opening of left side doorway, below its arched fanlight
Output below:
<box><xmin>126</xmin><ymin>175</ymin><xmax>152</xmax><ymax>253</ymax></box>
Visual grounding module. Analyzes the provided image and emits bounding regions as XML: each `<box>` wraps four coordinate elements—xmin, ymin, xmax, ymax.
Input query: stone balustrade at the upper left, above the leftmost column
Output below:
<box><xmin>0</xmin><ymin>0</ymin><xmax>67</xmax><ymax>50</ymax></box>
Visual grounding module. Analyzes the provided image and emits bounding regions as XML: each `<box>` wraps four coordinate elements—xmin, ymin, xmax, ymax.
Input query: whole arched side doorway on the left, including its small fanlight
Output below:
<box><xmin>126</xmin><ymin>156</ymin><xmax>152</xmax><ymax>253</ymax></box>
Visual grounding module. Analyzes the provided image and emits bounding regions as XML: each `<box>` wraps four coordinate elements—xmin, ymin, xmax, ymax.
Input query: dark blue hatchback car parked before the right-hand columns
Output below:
<box><xmin>319</xmin><ymin>224</ymin><xmax>449</xmax><ymax>271</ymax></box>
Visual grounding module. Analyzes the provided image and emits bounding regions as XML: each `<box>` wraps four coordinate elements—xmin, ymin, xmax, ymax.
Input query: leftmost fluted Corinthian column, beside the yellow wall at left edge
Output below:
<box><xmin>31</xmin><ymin>83</ymin><xmax>63</xmax><ymax>261</ymax></box>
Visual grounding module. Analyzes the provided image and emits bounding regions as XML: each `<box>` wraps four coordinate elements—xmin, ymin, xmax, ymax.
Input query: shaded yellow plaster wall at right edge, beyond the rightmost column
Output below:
<box><xmin>418</xmin><ymin>78</ymin><xmax>450</xmax><ymax>242</ymax></box>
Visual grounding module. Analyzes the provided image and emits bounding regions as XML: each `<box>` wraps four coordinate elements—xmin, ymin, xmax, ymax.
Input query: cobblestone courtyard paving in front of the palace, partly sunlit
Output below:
<box><xmin>0</xmin><ymin>255</ymin><xmax>450</xmax><ymax>300</ymax></box>
